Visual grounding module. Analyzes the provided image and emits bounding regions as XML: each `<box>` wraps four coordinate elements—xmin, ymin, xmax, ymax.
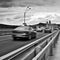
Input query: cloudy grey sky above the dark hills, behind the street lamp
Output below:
<box><xmin>0</xmin><ymin>0</ymin><xmax>60</xmax><ymax>25</ymax></box>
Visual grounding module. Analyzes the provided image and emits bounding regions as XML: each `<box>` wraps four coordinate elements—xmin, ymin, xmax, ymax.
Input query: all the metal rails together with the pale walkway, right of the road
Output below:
<box><xmin>0</xmin><ymin>30</ymin><xmax>60</xmax><ymax>60</ymax></box>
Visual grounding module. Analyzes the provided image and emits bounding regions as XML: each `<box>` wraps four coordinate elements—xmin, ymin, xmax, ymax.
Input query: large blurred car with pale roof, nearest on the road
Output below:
<box><xmin>12</xmin><ymin>26</ymin><xmax>36</xmax><ymax>40</ymax></box>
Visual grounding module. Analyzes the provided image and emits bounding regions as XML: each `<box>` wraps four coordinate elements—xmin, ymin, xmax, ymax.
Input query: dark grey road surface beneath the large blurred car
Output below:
<box><xmin>0</xmin><ymin>33</ymin><xmax>47</xmax><ymax>56</ymax></box>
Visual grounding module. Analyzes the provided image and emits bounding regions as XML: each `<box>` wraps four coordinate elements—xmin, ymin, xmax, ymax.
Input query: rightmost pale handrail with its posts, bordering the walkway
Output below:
<box><xmin>32</xmin><ymin>31</ymin><xmax>59</xmax><ymax>60</ymax></box>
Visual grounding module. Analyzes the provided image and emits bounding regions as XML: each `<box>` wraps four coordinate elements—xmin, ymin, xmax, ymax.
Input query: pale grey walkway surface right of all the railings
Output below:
<box><xmin>50</xmin><ymin>36</ymin><xmax>60</xmax><ymax>60</ymax></box>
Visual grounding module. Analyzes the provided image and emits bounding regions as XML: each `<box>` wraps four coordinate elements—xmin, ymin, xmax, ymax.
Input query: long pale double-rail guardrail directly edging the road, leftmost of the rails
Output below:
<box><xmin>0</xmin><ymin>31</ymin><xmax>57</xmax><ymax>60</ymax></box>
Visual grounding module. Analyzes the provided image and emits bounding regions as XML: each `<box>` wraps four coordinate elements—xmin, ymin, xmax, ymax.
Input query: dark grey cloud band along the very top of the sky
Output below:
<box><xmin>0</xmin><ymin>0</ymin><xmax>59</xmax><ymax>7</ymax></box>
